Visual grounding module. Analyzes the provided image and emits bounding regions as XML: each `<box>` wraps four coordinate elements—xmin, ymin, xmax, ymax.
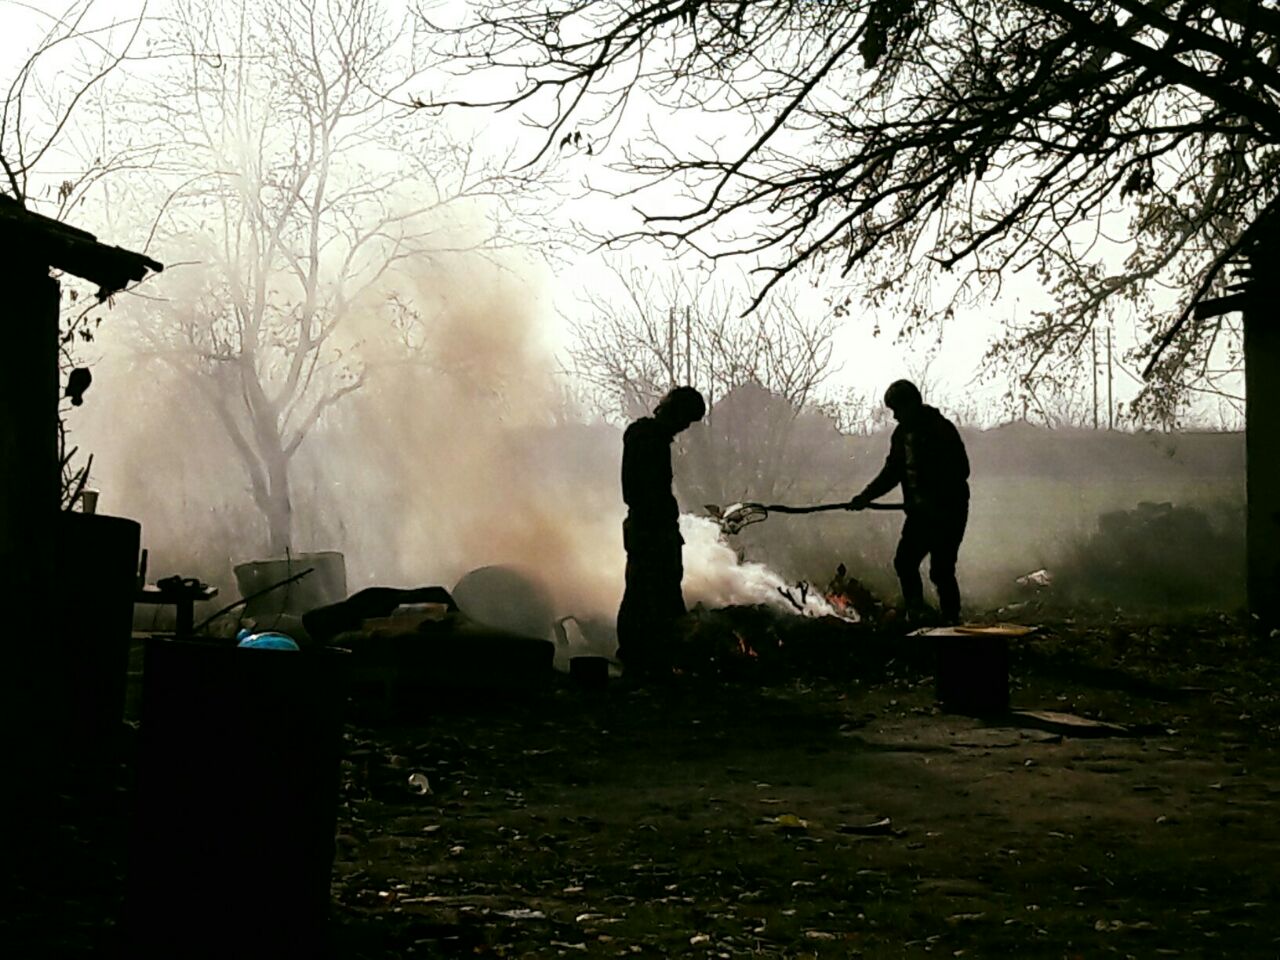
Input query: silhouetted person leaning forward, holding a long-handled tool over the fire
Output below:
<box><xmin>849</xmin><ymin>380</ymin><xmax>969</xmax><ymax>623</ymax></box>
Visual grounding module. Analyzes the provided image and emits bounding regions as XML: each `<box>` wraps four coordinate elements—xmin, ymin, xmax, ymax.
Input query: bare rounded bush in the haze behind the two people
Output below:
<box><xmin>570</xmin><ymin>264</ymin><xmax>837</xmax><ymax>502</ymax></box>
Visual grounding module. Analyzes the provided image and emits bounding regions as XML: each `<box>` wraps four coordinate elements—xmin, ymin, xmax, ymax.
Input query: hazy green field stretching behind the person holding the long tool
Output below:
<box><xmin>696</xmin><ymin>424</ymin><xmax>1244</xmax><ymax>604</ymax></box>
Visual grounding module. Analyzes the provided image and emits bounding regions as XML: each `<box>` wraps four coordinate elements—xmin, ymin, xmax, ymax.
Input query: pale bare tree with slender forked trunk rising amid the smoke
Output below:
<box><xmin>123</xmin><ymin>0</ymin><xmax>547</xmax><ymax>556</ymax></box>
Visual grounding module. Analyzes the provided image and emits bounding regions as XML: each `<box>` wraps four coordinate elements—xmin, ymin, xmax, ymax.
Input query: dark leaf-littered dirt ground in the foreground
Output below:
<box><xmin>0</xmin><ymin>611</ymin><xmax>1280</xmax><ymax>959</ymax></box>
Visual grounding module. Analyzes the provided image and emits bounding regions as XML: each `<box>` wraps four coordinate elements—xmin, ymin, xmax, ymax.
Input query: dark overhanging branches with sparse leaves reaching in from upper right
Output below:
<box><xmin>419</xmin><ymin>0</ymin><xmax>1280</xmax><ymax>416</ymax></box>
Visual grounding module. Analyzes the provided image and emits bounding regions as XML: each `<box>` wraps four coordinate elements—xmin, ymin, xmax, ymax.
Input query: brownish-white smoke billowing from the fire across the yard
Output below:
<box><xmin>74</xmin><ymin>253</ymin><xmax>826</xmax><ymax>640</ymax></box>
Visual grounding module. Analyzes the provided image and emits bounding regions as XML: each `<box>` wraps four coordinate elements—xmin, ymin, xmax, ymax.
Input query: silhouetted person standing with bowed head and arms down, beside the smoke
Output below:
<box><xmin>618</xmin><ymin>387</ymin><xmax>707</xmax><ymax>677</ymax></box>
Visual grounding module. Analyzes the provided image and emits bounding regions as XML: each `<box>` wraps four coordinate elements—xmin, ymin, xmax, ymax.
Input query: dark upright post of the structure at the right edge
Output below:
<box><xmin>1244</xmin><ymin>225</ymin><xmax>1280</xmax><ymax>630</ymax></box>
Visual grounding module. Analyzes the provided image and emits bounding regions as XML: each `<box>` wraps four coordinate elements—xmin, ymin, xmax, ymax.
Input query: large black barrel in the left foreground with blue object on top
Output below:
<box><xmin>128</xmin><ymin>639</ymin><xmax>342</xmax><ymax>957</ymax></box>
